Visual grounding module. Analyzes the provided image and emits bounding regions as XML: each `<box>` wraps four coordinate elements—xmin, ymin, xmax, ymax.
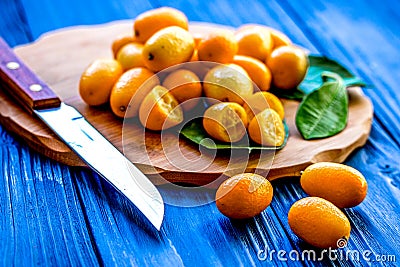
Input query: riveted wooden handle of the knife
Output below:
<box><xmin>0</xmin><ymin>37</ymin><xmax>61</xmax><ymax>112</ymax></box>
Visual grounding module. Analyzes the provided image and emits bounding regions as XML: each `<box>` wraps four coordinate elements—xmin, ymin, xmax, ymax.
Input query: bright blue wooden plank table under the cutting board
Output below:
<box><xmin>0</xmin><ymin>0</ymin><xmax>400</xmax><ymax>266</ymax></box>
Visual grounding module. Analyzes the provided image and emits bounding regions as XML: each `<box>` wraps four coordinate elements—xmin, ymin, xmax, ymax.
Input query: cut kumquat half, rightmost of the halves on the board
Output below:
<box><xmin>248</xmin><ymin>108</ymin><xmax>285</xmax><ymax>146</ymax></box>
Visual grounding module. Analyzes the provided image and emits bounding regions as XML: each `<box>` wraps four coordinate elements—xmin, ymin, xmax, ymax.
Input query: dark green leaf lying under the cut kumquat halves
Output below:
<box><xmin>180</xmin><ymin>118</ymin><xmax>289</xmax><ymax>153</ymax></box>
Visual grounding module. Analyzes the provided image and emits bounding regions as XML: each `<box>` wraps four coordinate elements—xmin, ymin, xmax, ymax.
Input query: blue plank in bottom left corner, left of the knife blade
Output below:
<box><xmin>0</xmin><ymin>127</ymin><xmax>97</xmax><ymax>266</ymax></box>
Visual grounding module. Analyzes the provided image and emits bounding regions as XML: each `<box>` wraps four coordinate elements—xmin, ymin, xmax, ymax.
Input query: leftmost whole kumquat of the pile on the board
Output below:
<box><xmin>79</xmin><ymin>59</ymin><xmax>123</xmax><ymax>106</ymax></box>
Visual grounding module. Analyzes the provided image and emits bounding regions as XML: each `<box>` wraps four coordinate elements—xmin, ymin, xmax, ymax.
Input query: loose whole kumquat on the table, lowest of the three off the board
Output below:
<box><xmin>288</xmin><ymin>197</ymin><xmax>351</xmax><ymax>248</ymax></box>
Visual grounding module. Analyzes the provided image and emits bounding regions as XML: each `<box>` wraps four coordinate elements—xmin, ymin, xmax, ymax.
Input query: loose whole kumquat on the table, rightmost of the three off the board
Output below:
<box><xmin>300</xmin><ymin>162</ymin><xmax>368</xmax><ymax>208</ymax></box>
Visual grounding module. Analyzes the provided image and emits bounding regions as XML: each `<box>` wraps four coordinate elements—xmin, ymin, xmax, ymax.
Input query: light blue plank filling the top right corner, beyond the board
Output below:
<box><xmin>276</xmin><ymin>1</ymin><xmax>400</xmax><ymax>149</ymax></box>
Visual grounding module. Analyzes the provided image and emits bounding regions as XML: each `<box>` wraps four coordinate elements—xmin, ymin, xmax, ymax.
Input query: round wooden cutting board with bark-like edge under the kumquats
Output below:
<box><xmin>0</xmin><ymin>21</ymin><xmax>373</xmax><ymax>185</ymax></box>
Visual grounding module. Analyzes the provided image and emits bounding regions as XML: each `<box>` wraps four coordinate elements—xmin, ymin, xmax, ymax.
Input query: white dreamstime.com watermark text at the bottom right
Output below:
<box><xmin>257</xmin><ymin>238</ymin><xmax>396</xmax><ymax>262</ymax></box>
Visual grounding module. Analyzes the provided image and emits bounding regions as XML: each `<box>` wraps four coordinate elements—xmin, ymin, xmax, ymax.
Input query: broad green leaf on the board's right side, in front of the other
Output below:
<box><xmin>296</xmin><ymin>72</ymin><xmax>349</xmax><ymax>140</ymax></box>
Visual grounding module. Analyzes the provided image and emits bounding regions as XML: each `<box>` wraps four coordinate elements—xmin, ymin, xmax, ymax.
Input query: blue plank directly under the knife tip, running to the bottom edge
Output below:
<box><xmin>70</xmin><ymin>171</ymin><xmax>186</xmax><ymax>266</ymax></box>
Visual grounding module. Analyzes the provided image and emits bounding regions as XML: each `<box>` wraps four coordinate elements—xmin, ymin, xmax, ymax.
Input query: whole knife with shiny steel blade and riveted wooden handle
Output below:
<box><xmin>0</xmin><ymin>37</ymin><xmax>164</xmax><ymax>230</ymax></box>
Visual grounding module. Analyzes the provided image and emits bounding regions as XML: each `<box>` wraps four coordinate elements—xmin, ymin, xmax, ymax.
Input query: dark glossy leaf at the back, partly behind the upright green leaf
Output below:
<box><xmin>271</xmin><ymin>55</ymin><xmax>366</xmax><ymax>100</ymax></box>
